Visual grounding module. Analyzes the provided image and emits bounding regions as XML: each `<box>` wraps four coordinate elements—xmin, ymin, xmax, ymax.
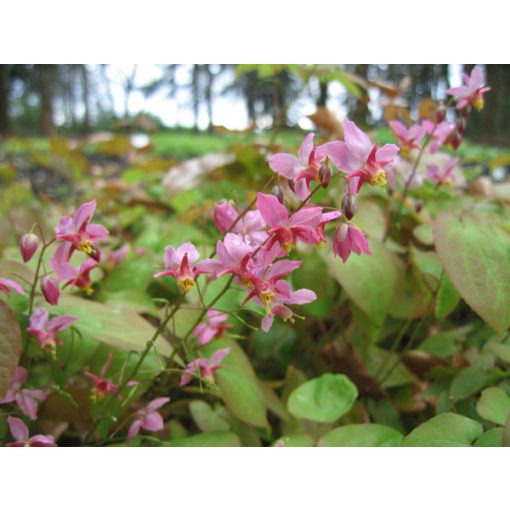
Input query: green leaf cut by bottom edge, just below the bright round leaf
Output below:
<box><xmin>318</xmin><ymin>423</ymin><xmax>403</xmax><ymax>446</ymax></box>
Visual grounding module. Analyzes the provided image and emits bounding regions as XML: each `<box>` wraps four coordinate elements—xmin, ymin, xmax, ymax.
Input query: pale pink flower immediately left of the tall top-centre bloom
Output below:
<box><xmin>268</xmin><ymin>133</ymin><xmax>327</xmax><ymax>200</ymax></box>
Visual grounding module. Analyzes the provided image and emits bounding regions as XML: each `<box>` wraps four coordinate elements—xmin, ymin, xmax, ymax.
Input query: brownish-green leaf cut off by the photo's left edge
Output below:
<box><xmin>0</xmin><ymin>301</ymin><xmax>21</xmax><ymax>398</ymax></box>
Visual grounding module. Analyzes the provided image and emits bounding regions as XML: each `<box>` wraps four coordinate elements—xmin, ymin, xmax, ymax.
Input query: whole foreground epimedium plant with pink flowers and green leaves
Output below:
<box><xmin>0</xmin><ymin>67</ymin><xmax>510</xmax><ymax>446</ymax></box>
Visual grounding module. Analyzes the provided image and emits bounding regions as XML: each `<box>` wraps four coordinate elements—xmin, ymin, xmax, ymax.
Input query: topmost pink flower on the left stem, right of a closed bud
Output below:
<box><xmin>55</xmin><ymin>200</ymin><xmax>108</xmax><ymax>261</ymax></box>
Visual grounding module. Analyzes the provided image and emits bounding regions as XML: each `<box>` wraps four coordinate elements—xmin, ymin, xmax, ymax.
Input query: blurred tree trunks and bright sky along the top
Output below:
<box><xmin>0</xmin><ymin>64</ymin><xmax>510</xmax><ymax>145</ymax></box>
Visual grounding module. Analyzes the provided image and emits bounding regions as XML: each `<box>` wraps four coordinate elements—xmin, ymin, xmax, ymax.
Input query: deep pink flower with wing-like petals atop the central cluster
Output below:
<box><xmin>257</xmin><ymin>193</ymin><xmax>322</xmax><ymax>252</ymax></box>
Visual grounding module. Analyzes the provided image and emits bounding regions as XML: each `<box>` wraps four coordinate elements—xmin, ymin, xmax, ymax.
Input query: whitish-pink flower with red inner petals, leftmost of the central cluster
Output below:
<box><xmin>154</xmin><ymin>243</ymin><xmax>206</xmax><ymax>292</ymax></box>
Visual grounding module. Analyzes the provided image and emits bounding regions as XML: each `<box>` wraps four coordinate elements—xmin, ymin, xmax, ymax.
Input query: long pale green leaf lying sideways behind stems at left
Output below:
<box><xmin>52</xmin><ymin>295</ymin><xmax>172</xmax><ymax>356</ymax></box>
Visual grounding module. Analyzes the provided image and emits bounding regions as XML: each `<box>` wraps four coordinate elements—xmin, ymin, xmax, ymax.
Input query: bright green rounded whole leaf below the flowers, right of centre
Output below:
<box><xmin>287</xmin><ymin>374</ymin><xmax>358</xmax><ymax>423</ymax></box>
